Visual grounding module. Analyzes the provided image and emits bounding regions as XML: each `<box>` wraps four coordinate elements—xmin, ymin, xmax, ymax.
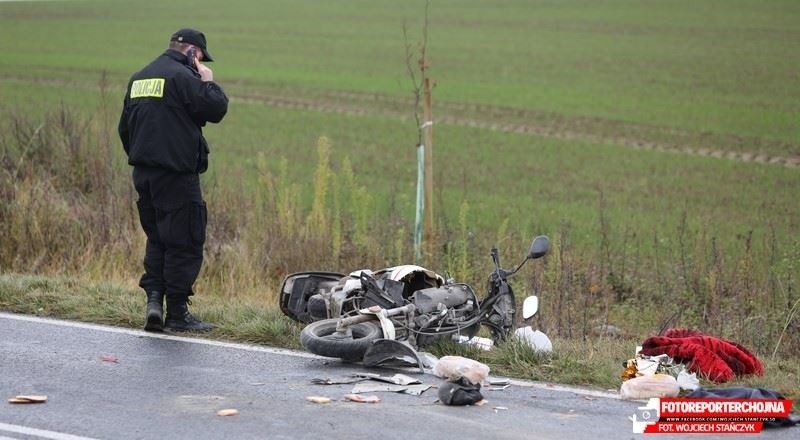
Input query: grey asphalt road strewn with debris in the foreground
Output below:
<box><xmin>0</xmin><ymin>313</ymin><xmax>800</xmax><ymax>440</ymax></box>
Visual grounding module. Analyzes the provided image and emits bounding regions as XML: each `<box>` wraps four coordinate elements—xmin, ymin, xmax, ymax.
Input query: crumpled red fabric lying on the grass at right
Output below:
<box><xmin>641</xmin><ymin>329</ymin><xmax>764</xmax><ymax>382</ymax></box>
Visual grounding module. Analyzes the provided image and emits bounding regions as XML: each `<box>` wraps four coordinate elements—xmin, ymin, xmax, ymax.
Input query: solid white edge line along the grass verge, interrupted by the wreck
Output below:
<box><xmin>0</xmin><ymin>312</ymin><xmax>620</xmax><ymax>400</ymax></box>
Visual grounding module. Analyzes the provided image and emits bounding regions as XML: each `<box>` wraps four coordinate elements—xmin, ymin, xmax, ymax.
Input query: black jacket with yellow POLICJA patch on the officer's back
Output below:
<box><xmin>119</xmin><ymin>50</ymin><xmax>228</xmax><ymax>173</ymax></box>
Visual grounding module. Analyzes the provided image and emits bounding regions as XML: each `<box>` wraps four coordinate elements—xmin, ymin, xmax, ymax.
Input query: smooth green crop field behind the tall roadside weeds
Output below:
<box><xmin>0</xmin><ymin>1</ymin><xmax>800</xmax><ymax>237</ymax></box>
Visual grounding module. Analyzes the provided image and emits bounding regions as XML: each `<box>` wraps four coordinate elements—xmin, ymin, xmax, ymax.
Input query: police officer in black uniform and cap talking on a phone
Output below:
<box><xmin>119</xmin><ymin>29</ymin><xmax>228</xmax><ymax>331</ymax></box>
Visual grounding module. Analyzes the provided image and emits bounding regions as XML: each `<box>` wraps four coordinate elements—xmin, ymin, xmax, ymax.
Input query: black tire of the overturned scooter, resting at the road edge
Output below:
<box><xmin>300</xmin><ymin>319</ymin><xmax>383</xmax><ymax>361</ymax></box>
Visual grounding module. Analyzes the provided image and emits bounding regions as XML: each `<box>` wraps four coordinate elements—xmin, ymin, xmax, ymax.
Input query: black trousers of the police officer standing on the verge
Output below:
<box><xmin>133</xmin><ymin>167</ymin><xmax>208</xmax><ymax>302</ymax></box>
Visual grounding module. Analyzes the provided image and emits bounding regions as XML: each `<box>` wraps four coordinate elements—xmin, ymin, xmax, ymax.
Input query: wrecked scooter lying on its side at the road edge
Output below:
<box><xmin>280</xmin><ymin>235</ymin><xmax>550</xmax><ymax>361</ymax></box>
